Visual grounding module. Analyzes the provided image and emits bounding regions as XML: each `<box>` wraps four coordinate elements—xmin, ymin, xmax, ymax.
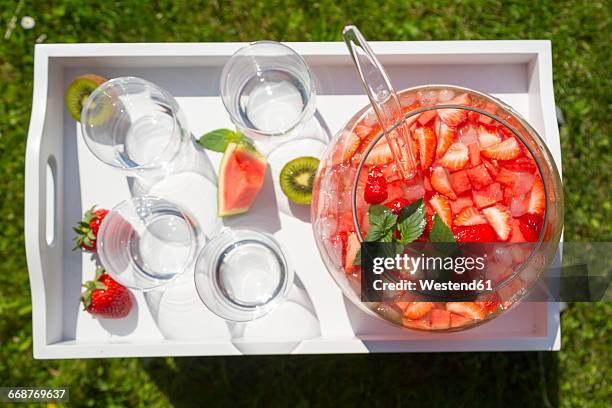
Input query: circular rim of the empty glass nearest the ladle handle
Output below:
<box><xmin>219</xmin><ymin>40</ymin><xmax>316</xmax><ymax>137</ymax></box>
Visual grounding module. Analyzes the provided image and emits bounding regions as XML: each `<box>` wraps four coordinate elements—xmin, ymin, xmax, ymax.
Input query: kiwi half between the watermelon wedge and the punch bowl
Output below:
<box><xmin>280</xmin><ymin>156</ymin><xmax>319</xmax><ymax>204</ymax></box>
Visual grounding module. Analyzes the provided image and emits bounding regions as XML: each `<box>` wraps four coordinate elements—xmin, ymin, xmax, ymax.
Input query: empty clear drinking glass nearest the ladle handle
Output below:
<box><xmin>220</xmin><ymin>41</ymin><xmax>316</xmax><ymax>139</ymax></box>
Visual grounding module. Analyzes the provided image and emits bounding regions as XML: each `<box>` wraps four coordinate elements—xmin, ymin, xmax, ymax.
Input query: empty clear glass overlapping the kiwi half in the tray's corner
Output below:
<box><xmin>81</xmin><ymin>77</ymin><xmax>191</xmax><ymax>175</ymax></box>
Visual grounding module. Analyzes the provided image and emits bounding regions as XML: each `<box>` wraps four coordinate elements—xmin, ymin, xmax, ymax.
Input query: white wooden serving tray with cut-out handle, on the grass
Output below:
<box><xmin>25</xmin><ymin>41</ymin><xmax>561</xmax><ymax>358</ymax></box>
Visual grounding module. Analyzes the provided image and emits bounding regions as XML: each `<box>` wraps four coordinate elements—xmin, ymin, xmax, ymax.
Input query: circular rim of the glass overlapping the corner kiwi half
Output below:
<box><xmin>80</xmin><ymin>75</ymin><xmax>181</xmax><ymax>171</ymax></box>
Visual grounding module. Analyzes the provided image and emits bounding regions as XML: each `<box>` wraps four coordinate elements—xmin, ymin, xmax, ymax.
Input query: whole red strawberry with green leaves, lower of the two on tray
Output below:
<box><xmin>81</xmin><ymin>267</ymin><xmax>132</xmax><ymax>319</ymax></box>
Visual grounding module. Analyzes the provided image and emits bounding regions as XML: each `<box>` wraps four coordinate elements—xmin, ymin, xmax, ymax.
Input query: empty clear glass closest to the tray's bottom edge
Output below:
<box><xmin>194</xmin><ymin>228</ymin><xmax>294</xmax><ymax>322</ymax></box>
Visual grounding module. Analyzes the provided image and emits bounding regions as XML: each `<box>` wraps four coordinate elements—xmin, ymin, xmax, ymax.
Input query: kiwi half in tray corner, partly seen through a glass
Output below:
<box><xmin>66</xmin><ymin>74</ymin><xmax>113</xmax><ymax>125</ymax></box>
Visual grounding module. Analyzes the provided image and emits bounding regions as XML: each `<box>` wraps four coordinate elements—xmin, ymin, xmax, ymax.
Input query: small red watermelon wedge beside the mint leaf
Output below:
<box><xmin>218</xmin><ymin>143</ymin><xmax>267</xmax><ymax>217</ymax></box>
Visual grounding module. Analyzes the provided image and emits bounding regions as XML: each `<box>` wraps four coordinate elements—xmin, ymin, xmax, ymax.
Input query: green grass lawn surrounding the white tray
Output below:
<box><xmin>0</xmin><ymin>0</ymin><xmax>612</xmax><ymax>407</ymax></box>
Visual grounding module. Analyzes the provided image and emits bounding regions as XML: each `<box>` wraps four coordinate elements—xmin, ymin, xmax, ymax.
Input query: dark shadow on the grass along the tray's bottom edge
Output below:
<box><xmin>142</xmin><ymin>352</ymin><xmax>559</xmax><ymax>407</ymax></box>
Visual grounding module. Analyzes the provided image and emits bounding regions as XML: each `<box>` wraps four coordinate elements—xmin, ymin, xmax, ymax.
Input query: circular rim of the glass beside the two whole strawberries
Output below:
<box><xmin>96</xmin><ymin>195</ymin><xmax>198</xmax><ymax>292</ymax></box>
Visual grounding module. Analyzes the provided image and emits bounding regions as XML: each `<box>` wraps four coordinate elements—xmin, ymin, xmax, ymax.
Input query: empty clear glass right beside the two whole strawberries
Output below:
<box><xmin>97</xmin><ymin>196</ymin><xmax>199</xmax><ymax>291</ymax></box>
